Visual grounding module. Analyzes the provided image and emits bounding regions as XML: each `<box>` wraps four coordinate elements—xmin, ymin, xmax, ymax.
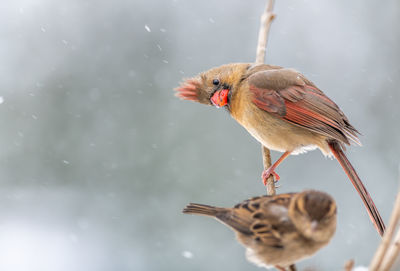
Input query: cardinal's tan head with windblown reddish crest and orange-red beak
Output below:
<box><xmin>175</xmin><ymin>63</ymin><xmax>250</xmax><ymax>108</ymax></box>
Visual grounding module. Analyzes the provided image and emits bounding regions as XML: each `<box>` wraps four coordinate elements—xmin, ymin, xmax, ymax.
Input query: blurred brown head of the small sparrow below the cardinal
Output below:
<box><xmin>289</xmin><ymin>190</ymin><xmax>336</xmax><ymax>242</ymax></box>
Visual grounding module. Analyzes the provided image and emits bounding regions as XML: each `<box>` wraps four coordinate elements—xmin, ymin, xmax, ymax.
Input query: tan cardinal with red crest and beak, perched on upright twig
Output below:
<box><xmin>176</xmin><ymin>63</ymin><xmax>385</xmax><ymax>235</ymax></box>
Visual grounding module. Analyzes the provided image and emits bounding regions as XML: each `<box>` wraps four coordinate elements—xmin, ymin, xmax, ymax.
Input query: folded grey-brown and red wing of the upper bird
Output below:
<box><xmin>248</xmin><ymin>69</ymin><xmax>360</xmax><ymax>147</ymax></box>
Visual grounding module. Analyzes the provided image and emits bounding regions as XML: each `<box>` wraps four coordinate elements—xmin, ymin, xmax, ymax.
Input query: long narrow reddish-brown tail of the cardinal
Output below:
<box><xmin>329</xmin><ymin>141</ymin><xmax>385</xmax><ymax>235</ymax></box>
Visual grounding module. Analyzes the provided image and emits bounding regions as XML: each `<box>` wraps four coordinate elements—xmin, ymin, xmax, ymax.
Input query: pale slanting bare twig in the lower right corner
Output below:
<box><xmin>369</xmin><ymin>185</ymin><xmax>400</xmax><ymax>271</ymax></box>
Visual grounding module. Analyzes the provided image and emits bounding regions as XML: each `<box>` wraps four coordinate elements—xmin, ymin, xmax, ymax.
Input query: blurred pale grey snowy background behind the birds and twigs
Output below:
<box><xmin>0</xmin><ymin>0</ymin><xmax>400</xmax><ymax>271</ymax></box>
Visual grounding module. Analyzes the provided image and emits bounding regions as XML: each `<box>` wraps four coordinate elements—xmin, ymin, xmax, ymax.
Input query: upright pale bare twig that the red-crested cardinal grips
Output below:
<box><xmin>256</xmin><ymin>0</ymin><xmax>276</xmax><ymax>195</ymax></box>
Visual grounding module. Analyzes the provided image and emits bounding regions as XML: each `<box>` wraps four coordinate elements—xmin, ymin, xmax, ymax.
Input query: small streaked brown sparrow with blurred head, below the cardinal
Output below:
<box><xmin>183</xmin><ymin>190</ymin><xmax>336</xmax><ymax>270</ymax></box>
